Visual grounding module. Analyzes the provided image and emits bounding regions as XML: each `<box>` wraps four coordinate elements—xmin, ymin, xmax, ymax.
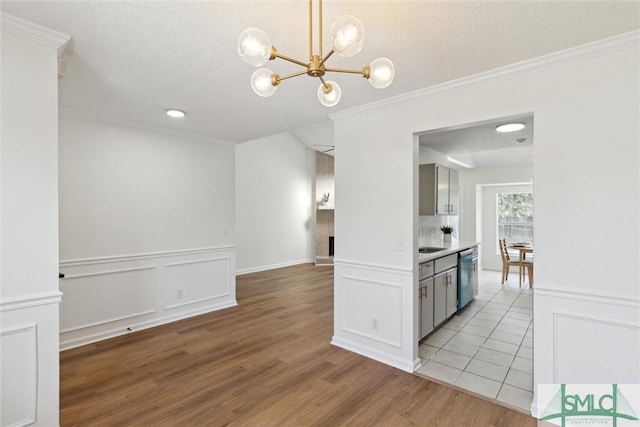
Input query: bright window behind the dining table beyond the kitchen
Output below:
<box><xmin>497</xmin><ymin>193</ymin><xmax>533</xmax><ymax>244</ymax></box>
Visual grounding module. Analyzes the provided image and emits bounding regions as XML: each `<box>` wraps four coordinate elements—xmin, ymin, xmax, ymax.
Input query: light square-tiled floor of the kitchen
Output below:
<box><xmin>418</xmin><ymin>270</ymin><xmax>533</xmax><ymax>413</ymax></box>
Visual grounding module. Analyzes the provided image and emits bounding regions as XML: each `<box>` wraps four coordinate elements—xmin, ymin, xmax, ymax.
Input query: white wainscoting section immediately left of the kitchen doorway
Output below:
<box><xmin>332</xmin><ymin>260</ymin><xmax>415</xmax><ymax>372</ymax></box>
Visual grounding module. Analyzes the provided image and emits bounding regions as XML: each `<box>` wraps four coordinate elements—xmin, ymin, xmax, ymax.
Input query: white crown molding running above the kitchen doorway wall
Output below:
<box><xmin>329</xmin><ymin>30</ymin><xmax>640</xmax><ymax>120</ymax></box>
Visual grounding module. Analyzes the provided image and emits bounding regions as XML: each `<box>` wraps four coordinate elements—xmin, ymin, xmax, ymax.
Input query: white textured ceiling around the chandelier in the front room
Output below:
<box><xmin>1</xmin><ymin>0</ymin><xmax>640</xmax><ymax>146</ymax></box>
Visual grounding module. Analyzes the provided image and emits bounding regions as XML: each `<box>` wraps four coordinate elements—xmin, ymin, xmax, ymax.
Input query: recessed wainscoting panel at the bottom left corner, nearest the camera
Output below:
<box><xmin>0</xmin><ymin>324</ymin><xmax>38</xmax><ymax>426</ymax></box>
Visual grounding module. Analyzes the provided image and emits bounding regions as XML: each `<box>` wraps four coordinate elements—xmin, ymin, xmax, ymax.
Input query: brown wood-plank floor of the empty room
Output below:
<box><xmin>60</xmin><ymin>264</ymin><xmax>535</xmax><ymax>427</ymax></box>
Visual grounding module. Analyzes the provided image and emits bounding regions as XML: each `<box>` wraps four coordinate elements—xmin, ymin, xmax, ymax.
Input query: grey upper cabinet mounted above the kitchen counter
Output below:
<box><xmin>419</xmin><ymin>163</ymin><xmax>459</xmax><ymax>215</ymax></box>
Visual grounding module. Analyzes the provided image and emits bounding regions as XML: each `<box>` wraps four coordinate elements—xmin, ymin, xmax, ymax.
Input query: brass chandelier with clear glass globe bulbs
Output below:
<box><xmin>238</xmin><ymin>0</ymin><xmax>395</xmax><ymax>107</ymax></box>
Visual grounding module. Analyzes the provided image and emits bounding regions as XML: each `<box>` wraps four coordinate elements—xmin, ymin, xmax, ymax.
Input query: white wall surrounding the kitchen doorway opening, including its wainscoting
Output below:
<box><xmin>332</xmin><ymin>32</ymin><xmax>640</xmax><ymax>409</ymax></box>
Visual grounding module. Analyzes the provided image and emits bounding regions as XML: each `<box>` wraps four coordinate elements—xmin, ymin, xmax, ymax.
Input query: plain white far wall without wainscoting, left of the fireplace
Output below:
<box><xmin>235</xmin><ymin>133</ymin><xmax>315</xmax><ymax>274</ymax></box>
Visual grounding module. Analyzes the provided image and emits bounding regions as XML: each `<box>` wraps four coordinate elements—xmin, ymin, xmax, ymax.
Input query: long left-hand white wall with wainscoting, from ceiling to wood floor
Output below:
<box><xmin>60</xmin><ymin>109</ymin><xmax>236</xmax><ymax>348</ymax></box>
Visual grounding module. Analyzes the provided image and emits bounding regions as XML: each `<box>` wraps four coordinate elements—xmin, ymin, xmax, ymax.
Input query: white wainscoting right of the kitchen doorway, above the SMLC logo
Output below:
<box><xmin>531</xmin><ymin>283</ymin><xmax>640</xmax><ymax>416</ymax></box>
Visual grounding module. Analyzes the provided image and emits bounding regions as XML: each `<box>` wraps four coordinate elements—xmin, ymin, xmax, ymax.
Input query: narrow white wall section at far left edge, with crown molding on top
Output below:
<box><xmin>0</xmin><ymin>14</ymin><xmax>69</xmax><ymax>426</ymax></box>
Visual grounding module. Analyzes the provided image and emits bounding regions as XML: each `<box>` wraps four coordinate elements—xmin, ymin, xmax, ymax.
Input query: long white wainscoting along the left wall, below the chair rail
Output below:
<box><xmin>60</xmin><ymin>246</ymin><xmax>237</xmax><ymax>349</ymax></box>
